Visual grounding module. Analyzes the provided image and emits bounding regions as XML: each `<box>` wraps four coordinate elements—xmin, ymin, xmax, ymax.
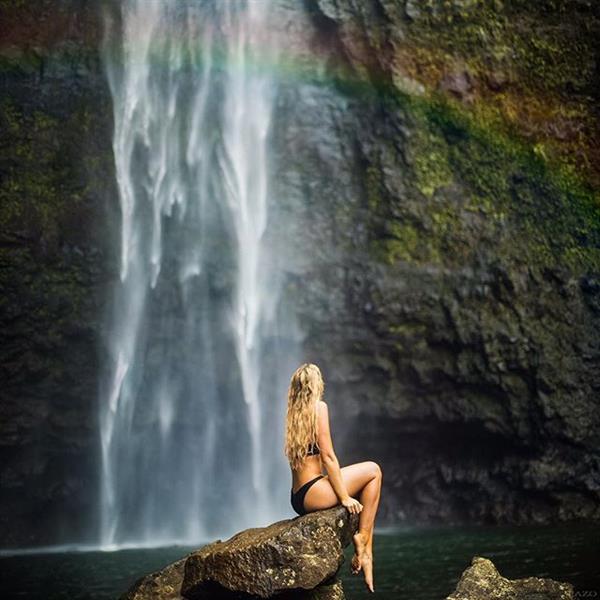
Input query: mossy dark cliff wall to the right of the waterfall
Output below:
<box><xmin>276</xmin><ymin>0</ymin><xmax>600</xmax><ymax>522</ymax></box>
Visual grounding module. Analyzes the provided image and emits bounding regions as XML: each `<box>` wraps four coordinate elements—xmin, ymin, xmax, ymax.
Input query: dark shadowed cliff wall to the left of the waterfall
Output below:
<box><xmin>0</xmin><ymin>0</ymin><xmax>118</xmax><ymax>547</ymax></box>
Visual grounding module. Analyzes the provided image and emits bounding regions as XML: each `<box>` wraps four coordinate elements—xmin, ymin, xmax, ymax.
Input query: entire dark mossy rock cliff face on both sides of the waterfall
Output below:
<box><xmin>0</xmin><ymin>0</ymin><xmax>600</xmax><ymax>546</ymax></box>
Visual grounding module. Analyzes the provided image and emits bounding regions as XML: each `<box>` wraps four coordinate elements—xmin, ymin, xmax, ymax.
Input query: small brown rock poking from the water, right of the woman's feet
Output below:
<box><xmin>446</xmin><ymin>556</ymin><xmax>574</xmax><ymax>600</ymax></box>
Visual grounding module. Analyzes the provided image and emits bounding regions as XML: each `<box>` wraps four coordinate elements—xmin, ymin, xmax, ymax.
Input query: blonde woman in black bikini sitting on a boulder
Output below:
<box><xmin>285</xmin><ymin>363</ymin><xmax>382</xmax><ymax>592</ymax></box>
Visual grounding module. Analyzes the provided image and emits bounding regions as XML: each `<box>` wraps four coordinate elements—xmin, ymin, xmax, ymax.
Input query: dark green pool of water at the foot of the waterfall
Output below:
<box><xmin>0</xmin><ymin>523</ymin><xmax>600</xmax><ymax>600</ymax></box>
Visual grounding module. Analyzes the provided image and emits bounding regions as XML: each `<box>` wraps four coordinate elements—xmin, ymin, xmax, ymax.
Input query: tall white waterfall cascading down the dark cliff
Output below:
<box><xmin>100</xmin><ymin>0</ymin><xmax>297</xmax><ymax>547</ymax></box>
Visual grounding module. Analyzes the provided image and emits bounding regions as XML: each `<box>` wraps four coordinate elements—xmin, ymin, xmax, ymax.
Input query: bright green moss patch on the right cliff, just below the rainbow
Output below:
<box><xmin>366</xmin><ymin>72</ymin><xmax>600</xmax><ymax>270</ymax></box>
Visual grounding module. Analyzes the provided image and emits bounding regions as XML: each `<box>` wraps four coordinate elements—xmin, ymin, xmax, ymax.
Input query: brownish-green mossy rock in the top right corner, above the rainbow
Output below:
<box><xmin>399</xmin><ymin>0</ymin><xmax>600</xmax><ymax>190</ymax></box>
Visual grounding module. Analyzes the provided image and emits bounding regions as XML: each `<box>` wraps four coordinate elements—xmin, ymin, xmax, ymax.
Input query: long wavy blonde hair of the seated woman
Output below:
<box><xmin>285</xmin><ymin>363</ymin><xmax>325</xmax><ymax>470</ymax></box>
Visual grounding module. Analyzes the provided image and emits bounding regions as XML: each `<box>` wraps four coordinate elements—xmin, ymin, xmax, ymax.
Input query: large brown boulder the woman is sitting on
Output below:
<box><xmin>121</xmin><ymin>506</ymin><xmax>358</xmax><ymax>600</ymax></box>
